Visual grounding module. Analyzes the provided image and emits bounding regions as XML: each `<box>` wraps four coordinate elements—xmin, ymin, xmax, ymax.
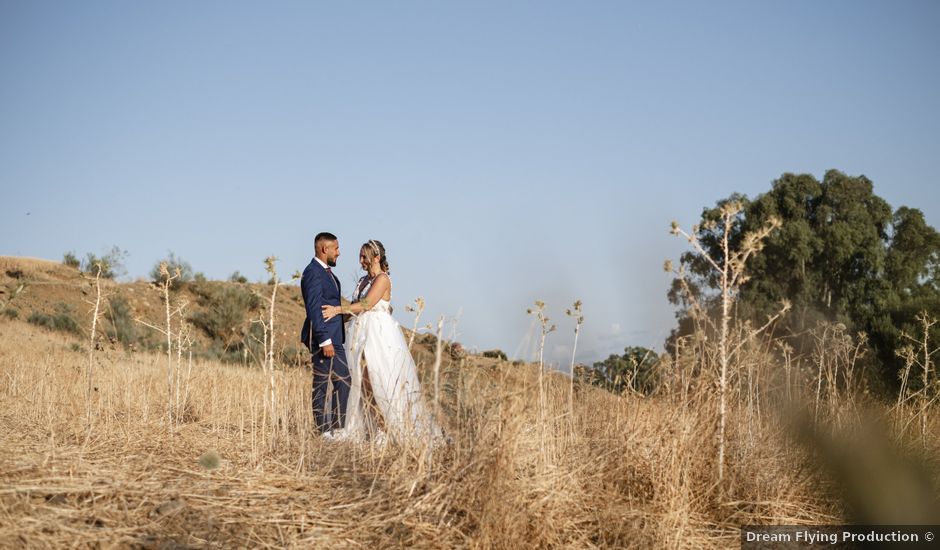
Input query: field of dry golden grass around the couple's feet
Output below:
<box><xmin>0</xmin><ymin>260</ymin><xmax>940</xmax><ymax>548</ymax></box>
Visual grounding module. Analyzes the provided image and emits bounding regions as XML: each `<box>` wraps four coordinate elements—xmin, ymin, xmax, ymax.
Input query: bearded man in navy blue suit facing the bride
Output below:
<box><xmin>300</xmin><ymin>233</ymin><xmax>349</xmax><ymax>437</ymax></box>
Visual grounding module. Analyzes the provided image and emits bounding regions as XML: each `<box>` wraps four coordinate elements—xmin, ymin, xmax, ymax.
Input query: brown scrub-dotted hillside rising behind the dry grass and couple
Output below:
<box><xmin>0</xmin><ymin>256</ymin><xmax>466</xmax><ymax>374</ymax></box>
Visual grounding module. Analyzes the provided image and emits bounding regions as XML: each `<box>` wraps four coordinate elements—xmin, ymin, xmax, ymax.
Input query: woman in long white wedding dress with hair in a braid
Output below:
<box><xmin>323</xmin><ymin>240</ymin><xmax>441</xmax><ymax>442</ymax></box>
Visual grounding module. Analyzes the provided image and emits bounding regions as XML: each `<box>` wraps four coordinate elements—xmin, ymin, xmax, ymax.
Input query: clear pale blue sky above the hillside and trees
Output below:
<box><xmin>0</xmin><ymin>0</ymin><xmax>940</xmax><ymax>366</ymax></box>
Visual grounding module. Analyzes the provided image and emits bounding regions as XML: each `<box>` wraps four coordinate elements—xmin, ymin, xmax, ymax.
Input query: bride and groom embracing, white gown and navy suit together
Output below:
<box><xmin>300</xmin><ymin>233</ymin><xmax>441</xmax><ymax>443</ymax></box>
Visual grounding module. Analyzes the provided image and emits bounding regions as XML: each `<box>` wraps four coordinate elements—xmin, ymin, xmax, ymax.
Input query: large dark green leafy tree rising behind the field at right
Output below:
<box><xmin>667</xmin><ymin>170</ymin><xmax>940</xmax><ymax>390</ymax></box>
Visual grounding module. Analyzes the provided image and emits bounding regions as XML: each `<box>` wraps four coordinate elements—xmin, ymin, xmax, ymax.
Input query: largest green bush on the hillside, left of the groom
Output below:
<box><xmin>189</xmin><ymin>281</ymin><xmax>261</xmax><ymax>351</ymax></box>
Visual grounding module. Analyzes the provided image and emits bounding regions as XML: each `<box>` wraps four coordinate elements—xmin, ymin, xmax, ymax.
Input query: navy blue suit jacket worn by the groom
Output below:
<box><xmin>300</xmin><ymin>258</ymin><xmax>346</xmax><ymax>352</ymax></box>
